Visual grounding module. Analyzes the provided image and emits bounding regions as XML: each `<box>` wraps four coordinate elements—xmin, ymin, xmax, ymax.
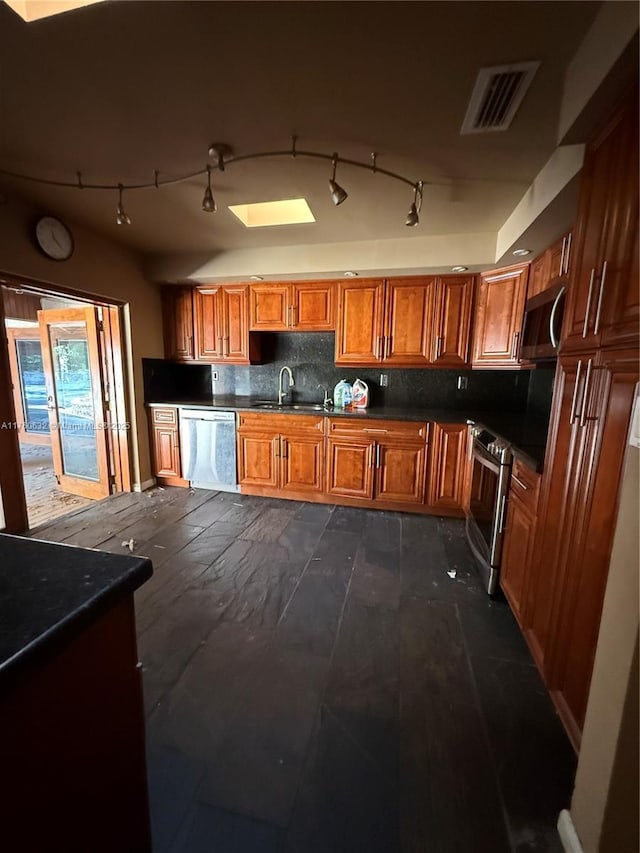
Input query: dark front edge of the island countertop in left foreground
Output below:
<box><xmin>0</xmin><ymin>534</ymin><xmax>153</xmax><ymax>693</ymax></box>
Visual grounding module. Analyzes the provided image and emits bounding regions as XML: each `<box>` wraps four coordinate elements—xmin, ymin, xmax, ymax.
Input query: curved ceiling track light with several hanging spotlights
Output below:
<box><xmin>5</xmin><ymin>136</ymin><xmax>423</xmax><ymax>226</ymax></box>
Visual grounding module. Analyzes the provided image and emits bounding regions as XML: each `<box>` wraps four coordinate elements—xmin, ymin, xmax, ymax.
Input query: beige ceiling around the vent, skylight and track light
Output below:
<box><xmin>0</xmin><ymin>0</ymin><xmax>600</xmax><ymax>272</ymax></box>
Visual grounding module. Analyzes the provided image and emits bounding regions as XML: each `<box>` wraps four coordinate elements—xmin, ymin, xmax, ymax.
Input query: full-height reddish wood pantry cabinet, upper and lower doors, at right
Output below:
<box><xmin>523</xmin><ymin>92</ymin><xmax>638</xmax><ymax>747</ymax></box>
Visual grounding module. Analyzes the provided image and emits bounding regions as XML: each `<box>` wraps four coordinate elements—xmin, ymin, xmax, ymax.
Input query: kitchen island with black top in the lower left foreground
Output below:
<box><xmin>0</xmin><ymin>535</ymin><xmax>152</xmax><ymax>853</ymax></box>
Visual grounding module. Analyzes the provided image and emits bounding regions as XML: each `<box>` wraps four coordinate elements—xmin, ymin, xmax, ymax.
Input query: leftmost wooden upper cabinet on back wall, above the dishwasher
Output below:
<box><xmin>163</xmin><ymin>284</ymin><xmax>260</xmax><ymax>364</ymax></box>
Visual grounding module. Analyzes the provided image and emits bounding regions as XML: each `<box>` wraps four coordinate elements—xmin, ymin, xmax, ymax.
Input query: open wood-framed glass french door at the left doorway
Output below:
<box><xmin>38</xmin><ymin>307</ymin><xmax>110</xmax><ymax>499</ymax></box>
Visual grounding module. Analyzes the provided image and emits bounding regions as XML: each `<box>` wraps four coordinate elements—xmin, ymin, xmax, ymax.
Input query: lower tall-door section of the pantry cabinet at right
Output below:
<box><xmin>523</xmin><ymin>349</ymin><xmax>638</xmax><ymax>747</ymax></box>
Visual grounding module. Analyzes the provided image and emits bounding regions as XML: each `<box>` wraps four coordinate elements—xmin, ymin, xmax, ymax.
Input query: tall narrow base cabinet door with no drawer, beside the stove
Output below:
<box><xmin>428</xmin><ymin>424</ymin><xmax>468</xmax><ymax>511</ymax></box>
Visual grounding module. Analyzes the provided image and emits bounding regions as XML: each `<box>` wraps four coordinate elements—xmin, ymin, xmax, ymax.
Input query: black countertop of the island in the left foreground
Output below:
<box><xmin>0</xmin><ymin>534</ymin><xmax>153</xmax><ymax>687</ymax></box>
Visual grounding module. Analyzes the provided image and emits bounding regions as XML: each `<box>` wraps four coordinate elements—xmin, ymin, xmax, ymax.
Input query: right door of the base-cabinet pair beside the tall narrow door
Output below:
<box><xmin>375</xmin><ymin>442</ymin><xmax>427</xmax><ymax>504</ymax></box>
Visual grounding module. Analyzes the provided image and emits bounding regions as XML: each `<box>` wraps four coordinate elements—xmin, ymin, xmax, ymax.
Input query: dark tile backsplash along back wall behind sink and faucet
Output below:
<box><xmin>143</xmin><ymin>332</ymin><xmax>528</xmax><ymax>412</ymax></box>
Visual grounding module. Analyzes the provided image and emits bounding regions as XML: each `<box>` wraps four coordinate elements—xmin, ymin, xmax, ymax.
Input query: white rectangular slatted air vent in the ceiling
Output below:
<box><xmin>460</xmin><ymin>62</ymin><xmax>540</xmax><ymax>134</ymax></box>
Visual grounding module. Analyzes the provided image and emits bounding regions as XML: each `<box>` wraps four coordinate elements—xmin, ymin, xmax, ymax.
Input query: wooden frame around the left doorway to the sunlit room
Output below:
<box><xmin>0</xmin><ymin>270</ymin><xmax>136</xmax><ymax>533</ymax></box>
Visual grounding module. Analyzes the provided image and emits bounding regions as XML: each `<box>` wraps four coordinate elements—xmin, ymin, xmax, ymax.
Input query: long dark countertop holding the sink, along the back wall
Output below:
<box><xmin>147</xmin><ymin>395</ymin><xmax>548</xmax><ymax>471</ymax></box>
